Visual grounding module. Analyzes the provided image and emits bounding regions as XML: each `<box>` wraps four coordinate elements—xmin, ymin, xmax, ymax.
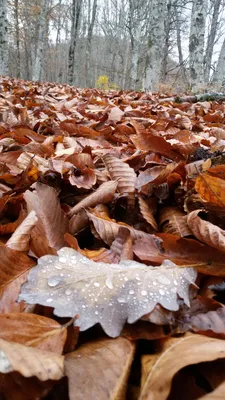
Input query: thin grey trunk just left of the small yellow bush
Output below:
<box><xmin>85</xmin><ymin>0</ymin><xmax>97</xmax><ymax>87</ymax></box>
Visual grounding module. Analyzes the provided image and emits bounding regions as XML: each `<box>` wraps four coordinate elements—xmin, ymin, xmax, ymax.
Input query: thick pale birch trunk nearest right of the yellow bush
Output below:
<box><xmin>143</xmin><ymin>0</ymin><xmax>167</xmax><ymax>91</ymax></box>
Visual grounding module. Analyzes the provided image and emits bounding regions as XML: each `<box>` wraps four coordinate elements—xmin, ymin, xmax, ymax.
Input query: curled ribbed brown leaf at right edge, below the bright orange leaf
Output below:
<box><xmin>187</xmin><ymin>210</ymin><xmax>225</xmax><ymax>252</ymax></box>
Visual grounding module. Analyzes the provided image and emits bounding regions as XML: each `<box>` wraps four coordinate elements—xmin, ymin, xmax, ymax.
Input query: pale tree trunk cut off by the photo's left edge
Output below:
<box><xmin>0</xmin><ymin>0</ymin><xmax>9</xmax><ymax>75</ymax></box>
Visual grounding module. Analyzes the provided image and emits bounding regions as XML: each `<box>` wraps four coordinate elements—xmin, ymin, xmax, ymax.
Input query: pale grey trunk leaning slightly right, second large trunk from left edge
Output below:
<box><xmin>32</xmin><ymin>0</ymin><xmax>49</xmax><ymax>81</ymax></box>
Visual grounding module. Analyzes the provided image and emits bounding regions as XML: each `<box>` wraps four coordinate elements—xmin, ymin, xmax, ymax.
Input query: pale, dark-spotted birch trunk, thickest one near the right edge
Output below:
<box><xmin>189</xmin><ymin>0</ymin><xmax>207</xmax><ymax>90</ymax></box>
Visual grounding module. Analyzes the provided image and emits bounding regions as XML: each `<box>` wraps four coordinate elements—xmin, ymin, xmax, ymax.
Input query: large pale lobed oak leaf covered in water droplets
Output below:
<box><xmin>19</xmin><ymin>248</ymin><xmax>197</xmax><ymax>337</ymax></box>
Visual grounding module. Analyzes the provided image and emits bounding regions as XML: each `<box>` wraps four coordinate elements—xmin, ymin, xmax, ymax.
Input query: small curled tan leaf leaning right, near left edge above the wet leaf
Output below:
<box><xmin>6</xmin><ymin>211</ymin><xmax>38</xmax><ymax>252</ymax></box>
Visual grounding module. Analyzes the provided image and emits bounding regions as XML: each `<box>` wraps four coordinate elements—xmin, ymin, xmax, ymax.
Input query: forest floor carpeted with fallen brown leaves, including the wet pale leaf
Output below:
<box><xmin>0</xmin><ymin>78</ymin><xmax>225</xmax><ymax>400</ymax></box>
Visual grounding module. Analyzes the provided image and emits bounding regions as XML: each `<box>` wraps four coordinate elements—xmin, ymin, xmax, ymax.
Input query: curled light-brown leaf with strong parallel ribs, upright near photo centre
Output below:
<box><xmin>103</xmin><ymin>154</ymin><xmax>137</xmax><ymax>193</ymax></box>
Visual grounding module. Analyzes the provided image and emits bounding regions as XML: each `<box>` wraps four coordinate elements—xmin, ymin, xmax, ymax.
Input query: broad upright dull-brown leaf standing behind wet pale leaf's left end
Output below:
<box><xmin>24</xmin><ymin>183</ymin><xmax>69</xmax><ymax>250</ymax></box>
